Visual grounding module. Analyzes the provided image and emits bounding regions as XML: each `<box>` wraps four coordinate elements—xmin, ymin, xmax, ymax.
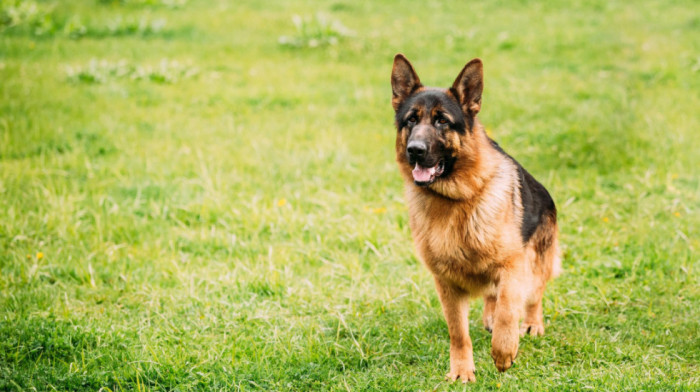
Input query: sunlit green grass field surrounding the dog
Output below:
<box><xmin>0</xmin><ymin>0</ymin><xmax>700</xmax><ymax>391</ymax></box>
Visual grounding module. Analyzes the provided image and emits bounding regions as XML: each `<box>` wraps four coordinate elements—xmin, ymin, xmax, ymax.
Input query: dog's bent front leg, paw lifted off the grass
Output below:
<box><xmin>491</xmin><ymin>277</ymin><xmax>523</xmax><ymax>372</ymax></box>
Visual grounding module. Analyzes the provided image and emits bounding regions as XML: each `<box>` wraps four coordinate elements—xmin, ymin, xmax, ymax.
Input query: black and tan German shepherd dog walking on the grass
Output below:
<box><xmin>391</xmin><ymin>54</ymin><xmax>561</xmax><ymax>383</ymax></box>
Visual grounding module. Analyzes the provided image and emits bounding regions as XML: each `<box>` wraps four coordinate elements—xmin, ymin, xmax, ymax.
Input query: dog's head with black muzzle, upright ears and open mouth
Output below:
<box><xmin>391</xmin><ymin>54</ymin><xmax>483</xmax><ymax>189</ymax></box>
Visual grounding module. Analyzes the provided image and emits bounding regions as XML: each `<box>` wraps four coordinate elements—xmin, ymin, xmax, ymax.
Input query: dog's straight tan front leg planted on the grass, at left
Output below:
<box><xmin>435</xmin><ymin>278</ymin><xmax>476</xmax><ymax>383</ymax></box>
